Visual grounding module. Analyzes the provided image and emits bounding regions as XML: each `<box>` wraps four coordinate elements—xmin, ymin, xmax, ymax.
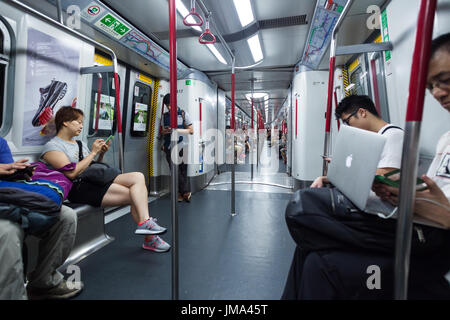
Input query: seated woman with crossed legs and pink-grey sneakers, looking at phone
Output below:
<box><xmin>41</xmin><ymin>106</ymin><xmax>170</xmax><ymax>252</ymax></box>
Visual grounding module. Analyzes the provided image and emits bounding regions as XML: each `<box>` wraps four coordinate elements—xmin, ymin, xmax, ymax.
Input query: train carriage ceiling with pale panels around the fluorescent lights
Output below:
<box><xmin>22</xmin><ymin>0</ymin><xmax>389</xmax><ymax>122</ymax></box>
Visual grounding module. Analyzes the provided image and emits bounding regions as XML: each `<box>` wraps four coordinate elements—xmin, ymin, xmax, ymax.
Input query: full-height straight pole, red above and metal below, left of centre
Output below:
<box><xmin>169</xmin><ymin>0</ymin><xmax>179</xmax><ymax>300</ymax></box>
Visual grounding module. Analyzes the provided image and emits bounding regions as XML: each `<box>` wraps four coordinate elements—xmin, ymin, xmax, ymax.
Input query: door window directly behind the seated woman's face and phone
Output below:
<box><xmin>89</xmin><ymin>73</ymin><xmax>120</xmax><ymax>136</ymax></box>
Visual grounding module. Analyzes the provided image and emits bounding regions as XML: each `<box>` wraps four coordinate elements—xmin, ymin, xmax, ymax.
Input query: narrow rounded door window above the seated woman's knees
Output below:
<box><xmin>130</xmin><ymin>82</ymin><xmax>152</xmax><ymax>137</ymax></box>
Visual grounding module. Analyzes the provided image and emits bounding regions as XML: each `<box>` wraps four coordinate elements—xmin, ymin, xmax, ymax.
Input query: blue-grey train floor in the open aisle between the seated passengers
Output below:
<box><xmin>71</xmin><ymin>190</ymin><xmax>295</xmax><ymax>300</ymax></box>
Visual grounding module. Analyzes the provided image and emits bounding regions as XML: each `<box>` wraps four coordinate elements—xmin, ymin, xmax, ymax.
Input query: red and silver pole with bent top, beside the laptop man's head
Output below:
<box><xmin>322</xmin><ymin>0</ymin><xmax>353</xmax><ymax>176</ymax></box>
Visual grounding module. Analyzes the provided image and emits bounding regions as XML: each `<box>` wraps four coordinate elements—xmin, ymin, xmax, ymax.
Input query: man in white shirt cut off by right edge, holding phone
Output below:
<box><xmin>375</xmin><ymin>33</ymin><xmax>450</xmax><ymax>229</ymax></box>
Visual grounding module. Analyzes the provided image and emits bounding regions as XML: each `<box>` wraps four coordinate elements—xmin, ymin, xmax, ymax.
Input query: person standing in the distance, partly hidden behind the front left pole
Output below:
<box><xmin>162</xmin><ymin>93</ymin><xmax>194</xmax><ymax>202</ymax></box>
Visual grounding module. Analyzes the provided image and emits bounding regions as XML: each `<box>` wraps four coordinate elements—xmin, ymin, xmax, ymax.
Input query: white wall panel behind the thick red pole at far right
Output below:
<box><xmin>382</xmin><ymin>0</ymin><xmax>450</xmax><ymax>157</ymax></box>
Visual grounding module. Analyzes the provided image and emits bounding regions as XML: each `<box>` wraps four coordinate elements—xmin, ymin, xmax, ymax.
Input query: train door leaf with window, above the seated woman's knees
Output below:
<box><xmin>124</xmin><ymin>70</ymin><xmax>154</xmax><ymax>182</ymax></box>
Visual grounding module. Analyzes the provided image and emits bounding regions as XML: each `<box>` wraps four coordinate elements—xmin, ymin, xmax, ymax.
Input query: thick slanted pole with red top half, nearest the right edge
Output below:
<box><xmin>395</xmin><ymin>0</ymin><xmax>436</xmax><ymax>300</ymax></box>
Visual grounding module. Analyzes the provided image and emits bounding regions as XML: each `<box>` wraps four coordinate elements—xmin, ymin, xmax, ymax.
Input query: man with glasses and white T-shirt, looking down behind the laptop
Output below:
<box><xmin>311</xmin><ymin>95</ymin><xmax>403</xmax><ymax>188</ymax></box>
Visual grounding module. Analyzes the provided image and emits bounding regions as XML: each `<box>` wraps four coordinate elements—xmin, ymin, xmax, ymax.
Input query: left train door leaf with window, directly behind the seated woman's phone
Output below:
<box><xmin>85</xmin><ymin>54</ymin><xmax>126</xmax><ymax>168</ymax></box>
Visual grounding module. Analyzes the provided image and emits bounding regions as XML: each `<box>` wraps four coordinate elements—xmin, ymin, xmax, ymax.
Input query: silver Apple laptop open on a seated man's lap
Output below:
<box><xmin>327</xmin><ymin>126</ymin><xmax>388</xmax><ymax>213</ymax></box>
